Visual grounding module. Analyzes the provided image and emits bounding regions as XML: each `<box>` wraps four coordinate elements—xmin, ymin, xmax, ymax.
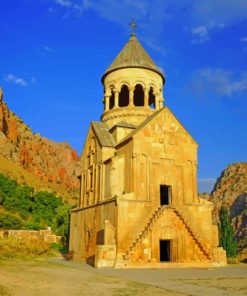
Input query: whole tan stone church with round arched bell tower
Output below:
<box><xmin>70</xmin><ymin>33</ymin><xmax>226</xmax><ymax>268</ymax></box>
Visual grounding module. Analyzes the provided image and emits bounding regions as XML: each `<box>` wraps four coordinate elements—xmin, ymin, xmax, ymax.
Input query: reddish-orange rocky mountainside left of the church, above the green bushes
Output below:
<box><xmin>0</xmin><ymin>89</ymin><xmax>80</xmax><ymax>199</ymax></box>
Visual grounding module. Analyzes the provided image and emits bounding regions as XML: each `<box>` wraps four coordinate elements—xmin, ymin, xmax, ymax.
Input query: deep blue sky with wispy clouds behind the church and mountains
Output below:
<box><xmin>0</xmin><ymin>0</ymin><xmax>247</xmax><ymax>191</ymax></box>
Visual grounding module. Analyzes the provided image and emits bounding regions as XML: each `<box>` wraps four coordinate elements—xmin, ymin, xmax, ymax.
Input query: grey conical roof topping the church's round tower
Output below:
<box><xmin>101</xmin><ymin>34</ymin><xmax>165</xmax><ymax>83</ymax></box>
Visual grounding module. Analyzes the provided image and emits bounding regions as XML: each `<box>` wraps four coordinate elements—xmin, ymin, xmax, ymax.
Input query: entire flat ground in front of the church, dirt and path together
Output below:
<box><xmin>0</xmin><ymin>258</ymin><xmax>247</xmax><ymax>296</ymax></box>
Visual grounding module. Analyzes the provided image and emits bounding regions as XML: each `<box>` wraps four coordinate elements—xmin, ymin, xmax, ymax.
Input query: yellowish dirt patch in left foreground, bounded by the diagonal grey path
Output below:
<box><xmin>0</xmin><ymin>260</ymin><xmax>183</xmax><ymax>296</ymax></box>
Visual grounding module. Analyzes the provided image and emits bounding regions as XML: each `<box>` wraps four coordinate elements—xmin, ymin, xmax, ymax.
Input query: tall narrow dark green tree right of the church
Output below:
<box><xmin>219</xmin><ymin>207</ymin><xmax>237</xmax><ymax>258</ymax></box>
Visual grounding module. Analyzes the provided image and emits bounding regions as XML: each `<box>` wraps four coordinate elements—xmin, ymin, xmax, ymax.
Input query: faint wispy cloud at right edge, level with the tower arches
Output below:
<box><xmin>189</xmin><ymin>68</ymin><xmax>247</xmax><ymax>97</ymax></box>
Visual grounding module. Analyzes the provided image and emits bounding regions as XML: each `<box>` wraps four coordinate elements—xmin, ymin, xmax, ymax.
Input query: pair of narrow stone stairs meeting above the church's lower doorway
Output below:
<box><xmin>123</xmin><ymin>205</ymin><xmax>212</xmax><ymax>262</ymax></box>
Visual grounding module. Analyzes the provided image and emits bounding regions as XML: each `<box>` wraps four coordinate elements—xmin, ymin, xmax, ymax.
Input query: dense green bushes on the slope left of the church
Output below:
<box><xmin>0</xmin><ymin>174</ymin><xmax>71</xmax><ymax>237</ymax></box>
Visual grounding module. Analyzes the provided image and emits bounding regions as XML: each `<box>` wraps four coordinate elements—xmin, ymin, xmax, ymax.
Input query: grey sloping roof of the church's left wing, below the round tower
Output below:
<box><xmin>91</xmin><ymin>121</ymin><xmax>116</xmax><ymax>148</ymax></box>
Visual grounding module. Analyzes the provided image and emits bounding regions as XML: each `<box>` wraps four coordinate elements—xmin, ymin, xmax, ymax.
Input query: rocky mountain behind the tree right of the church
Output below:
<box><xmin>205</xmin><ymin>162</ymin><xmax>247</xmax><ymax>251</ymax></box>
